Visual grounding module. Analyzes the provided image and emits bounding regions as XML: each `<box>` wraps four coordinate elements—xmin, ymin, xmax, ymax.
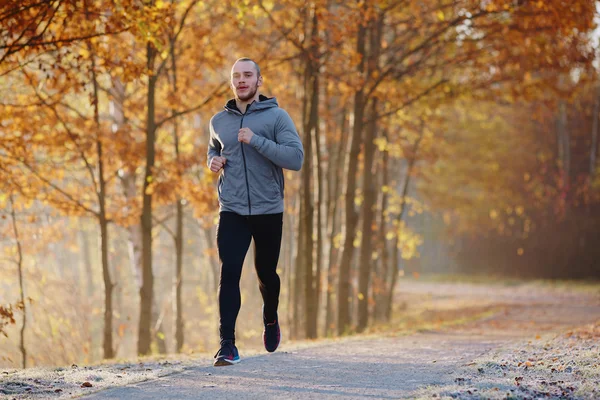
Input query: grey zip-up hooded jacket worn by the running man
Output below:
<box><xmin>208</xmin><ymin>95</ymin><xmax>304</xmax><ymax>215</ymax></box>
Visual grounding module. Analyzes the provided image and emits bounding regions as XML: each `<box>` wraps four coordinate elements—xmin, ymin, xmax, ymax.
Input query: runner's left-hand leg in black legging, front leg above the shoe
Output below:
<box><xmin>217</xmin><ymin>212</ymin><xmax>252</xmax><ymax>344</ymax></box>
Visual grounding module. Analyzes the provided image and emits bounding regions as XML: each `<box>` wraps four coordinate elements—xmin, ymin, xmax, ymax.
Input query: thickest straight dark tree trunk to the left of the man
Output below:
<box><xmin>138</xmin><ymin>39</ymin><xmax>158</xmax><ymax>355</ymax></box>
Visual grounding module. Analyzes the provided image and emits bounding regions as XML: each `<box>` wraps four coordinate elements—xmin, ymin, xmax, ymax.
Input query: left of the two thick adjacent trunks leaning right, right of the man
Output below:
<box><xmin>337</xmin><ymin>7</ymin><xmax>366</xmax><ymax>335</ymax></box>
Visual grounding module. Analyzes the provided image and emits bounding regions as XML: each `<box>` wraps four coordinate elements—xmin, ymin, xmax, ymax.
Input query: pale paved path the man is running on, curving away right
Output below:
<box><xmin>85</xmin><ymin>284</ymin><xmax>600</xmax><ymax>399</ymax></box>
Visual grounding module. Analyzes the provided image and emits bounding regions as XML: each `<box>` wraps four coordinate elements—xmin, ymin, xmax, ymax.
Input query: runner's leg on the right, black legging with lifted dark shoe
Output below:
<box><xmin>251</xmin><ymin>213</ymin><xmax>283</xmax><ymax>352</ymax></box>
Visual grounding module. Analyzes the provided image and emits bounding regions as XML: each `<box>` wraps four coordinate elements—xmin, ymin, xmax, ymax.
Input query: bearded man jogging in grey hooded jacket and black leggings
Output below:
<box><xmin>208</xmin><ymin>58</ymin><xmax>304</xmax><ymax>366</ymax></box>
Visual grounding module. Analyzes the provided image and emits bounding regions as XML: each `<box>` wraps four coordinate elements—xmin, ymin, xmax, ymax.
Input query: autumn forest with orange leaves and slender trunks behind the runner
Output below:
<box><xmin>0</xmin><ymin>0</ymin><xmax>600</xmax><ymax>367</ymax></box>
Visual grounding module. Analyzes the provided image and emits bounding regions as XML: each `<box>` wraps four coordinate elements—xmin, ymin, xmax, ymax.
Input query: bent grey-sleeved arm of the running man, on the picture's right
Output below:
<box><xmin>250</xmin><ymin>110</ymin><xmax>304</xmax><ymax>171</ymax></box>
